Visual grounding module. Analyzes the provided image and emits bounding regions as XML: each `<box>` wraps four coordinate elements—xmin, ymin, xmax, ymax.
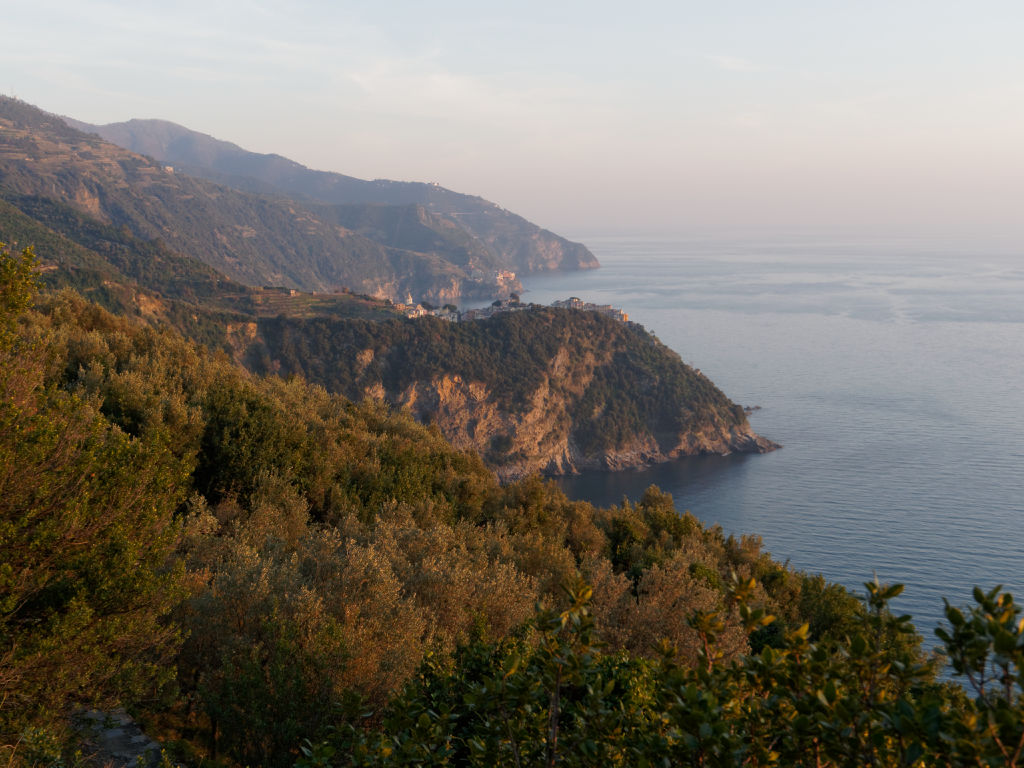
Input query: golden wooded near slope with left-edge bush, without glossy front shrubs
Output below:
<box><xmin>0</xmin><ymin>244</ymin><xmax>872</xmax><ymax>765</ymax></box>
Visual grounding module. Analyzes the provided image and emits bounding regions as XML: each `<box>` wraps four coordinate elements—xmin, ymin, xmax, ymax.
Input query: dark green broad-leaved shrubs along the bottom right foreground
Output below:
<box><xmin>307</xmin><ymin>579</ymin><xmax>1024</xmax><ymax>766</ymax></box>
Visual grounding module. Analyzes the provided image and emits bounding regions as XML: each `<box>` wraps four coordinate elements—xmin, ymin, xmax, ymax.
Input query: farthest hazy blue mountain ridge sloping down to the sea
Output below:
<box><xmin>66</xmin><ymin>118</ymin><xmax>598</xmax><ymax>273</ymax></box>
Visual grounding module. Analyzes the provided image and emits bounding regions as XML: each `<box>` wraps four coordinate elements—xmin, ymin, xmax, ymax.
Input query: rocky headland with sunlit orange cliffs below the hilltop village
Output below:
<box><xmin>246</xmin><ymin>308</ymin><xmax>777</xmax><ymax>479</ymax></box>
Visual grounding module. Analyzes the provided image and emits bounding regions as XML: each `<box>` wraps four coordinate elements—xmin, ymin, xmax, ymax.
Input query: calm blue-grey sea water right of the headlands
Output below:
<box><xmin>523</xmin><ymin>239</ymin><xmax>1024</xmax><ymax>644</ymax></box>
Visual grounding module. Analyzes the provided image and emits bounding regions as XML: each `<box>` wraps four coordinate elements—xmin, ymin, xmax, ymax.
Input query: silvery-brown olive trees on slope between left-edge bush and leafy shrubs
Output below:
<box><xmin>4</xmin><ymin>268</ymin><xmax>831</xmax><ymax>764</ymax></box>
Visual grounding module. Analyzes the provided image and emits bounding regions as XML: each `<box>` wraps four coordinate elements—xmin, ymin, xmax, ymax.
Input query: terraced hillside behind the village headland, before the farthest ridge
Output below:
<box><xmin>0</xmin><ymin>97</ymin><xmax>589</xmax><ymax>303</ymax></box>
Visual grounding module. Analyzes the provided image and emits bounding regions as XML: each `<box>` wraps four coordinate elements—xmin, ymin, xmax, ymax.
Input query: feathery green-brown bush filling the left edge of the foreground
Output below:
<box><xmin>0</xmin><ymin>251</ymin><xmax>187</xmax><ymax>749</ymax></box>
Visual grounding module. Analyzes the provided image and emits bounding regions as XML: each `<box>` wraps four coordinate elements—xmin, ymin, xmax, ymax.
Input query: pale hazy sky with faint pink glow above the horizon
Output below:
<box><xmin>8</xmin><ymin>0</ymin><xmax>1024</xmax><ymax>240</ymax></box>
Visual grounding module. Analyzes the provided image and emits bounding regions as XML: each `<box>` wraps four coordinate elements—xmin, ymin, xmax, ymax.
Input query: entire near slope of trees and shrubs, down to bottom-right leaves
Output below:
<box><xmin>6</xmin><ymin>249</ymin><xmax>1024</xmax><ymax>767</ymax></box>
